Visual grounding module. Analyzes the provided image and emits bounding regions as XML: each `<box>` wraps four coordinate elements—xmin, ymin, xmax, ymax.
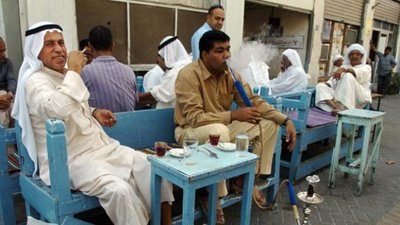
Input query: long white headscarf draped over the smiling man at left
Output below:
<box><xmin>11</xmin><ymin>22</ymin><xmax>62</xmax><ymax>174</ymax></box>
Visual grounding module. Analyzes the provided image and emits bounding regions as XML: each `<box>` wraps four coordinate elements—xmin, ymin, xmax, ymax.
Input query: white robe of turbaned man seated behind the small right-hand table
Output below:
<box><xmin>315</xmin><ymin>64</ymin><xmax>372</xmax><ymax>112</ymax></box>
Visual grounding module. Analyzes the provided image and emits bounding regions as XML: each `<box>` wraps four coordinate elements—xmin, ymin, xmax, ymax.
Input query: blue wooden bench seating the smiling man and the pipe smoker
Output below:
<box><xmin>16</xmin><ymin>109</ymin><xmax>281</xmax><ymax>224</ymax></box>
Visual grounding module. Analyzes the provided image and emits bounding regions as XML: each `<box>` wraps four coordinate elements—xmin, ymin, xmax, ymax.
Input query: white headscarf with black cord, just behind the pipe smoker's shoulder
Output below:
<box><xmin>158</xmin><ymin>36</ymin><xmax>192</xmax><ymax>68</ymax></box>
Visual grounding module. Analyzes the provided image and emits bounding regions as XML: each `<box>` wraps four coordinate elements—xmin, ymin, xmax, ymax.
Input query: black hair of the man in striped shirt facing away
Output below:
<box><xmin>89</xmin><ymin>26</ymin><xmax>113</xmax><ymax>51</ymax></box>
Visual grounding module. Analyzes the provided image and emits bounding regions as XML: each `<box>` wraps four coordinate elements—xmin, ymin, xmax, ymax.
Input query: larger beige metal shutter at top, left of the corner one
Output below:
<box><xmin>324</xmin><ymin>0</ymin><xmax>364</xmax><ymax>26</ymax></box>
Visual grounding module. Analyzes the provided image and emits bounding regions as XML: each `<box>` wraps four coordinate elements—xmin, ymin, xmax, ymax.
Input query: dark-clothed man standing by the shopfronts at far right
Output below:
<box><xmin>370</xmin><ymin>41</ymin><xmax>397</xmax><ymax>94</ymax></box>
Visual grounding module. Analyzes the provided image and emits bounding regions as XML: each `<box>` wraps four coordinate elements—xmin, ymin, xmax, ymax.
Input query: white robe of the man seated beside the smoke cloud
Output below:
<box><xmin>268</xmin><ymin>66</ymin><xmax>308</xmax><ymax>94</ymax></box>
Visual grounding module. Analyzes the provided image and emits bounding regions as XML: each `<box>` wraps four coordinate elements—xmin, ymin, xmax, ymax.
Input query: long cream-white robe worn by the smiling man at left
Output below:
<box><xmin>25</xmin><ymin>68</ymin><xmax>173</xmax><ymax>224</ymax></box>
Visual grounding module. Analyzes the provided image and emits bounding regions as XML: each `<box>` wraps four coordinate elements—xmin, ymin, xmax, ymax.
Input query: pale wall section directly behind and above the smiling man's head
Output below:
<box><xmin>19</xmin><ymin>0</ymin><xmax>78</xmax><ymax>51</ymax></box>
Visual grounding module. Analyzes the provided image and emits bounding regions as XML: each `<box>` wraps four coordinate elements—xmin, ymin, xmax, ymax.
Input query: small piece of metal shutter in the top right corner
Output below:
<box><xmin>374</xmin><ymin>0</ymin><xmax>400</xmax><ymax>24</ymax></box>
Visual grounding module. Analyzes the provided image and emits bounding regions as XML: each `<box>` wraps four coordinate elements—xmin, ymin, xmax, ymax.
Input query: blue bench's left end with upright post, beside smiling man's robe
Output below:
<box><xmin>16</xmin><ymin>120</ymin><xmax>100</xmax><ymax>224</ymax></box>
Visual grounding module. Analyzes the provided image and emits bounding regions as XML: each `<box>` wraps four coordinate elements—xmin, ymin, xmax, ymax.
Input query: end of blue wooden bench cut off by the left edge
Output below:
<box><xmin>0</xmin><ymin>127</ymin><xmax>20</xmax><ymax>225</ymax></box>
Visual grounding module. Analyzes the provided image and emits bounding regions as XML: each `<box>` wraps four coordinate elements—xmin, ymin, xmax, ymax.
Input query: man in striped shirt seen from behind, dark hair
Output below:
<box><xmin>82</xmin><ymin>26</ymin><xmax>137</xmax><ymax>112</ymax></box>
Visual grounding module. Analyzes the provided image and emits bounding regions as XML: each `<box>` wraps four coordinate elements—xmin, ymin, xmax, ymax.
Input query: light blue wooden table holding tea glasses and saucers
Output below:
<box><xmin>148</xmin><ymin>144</ymin><xmax>257</xmax><ymax>225</ymax></box>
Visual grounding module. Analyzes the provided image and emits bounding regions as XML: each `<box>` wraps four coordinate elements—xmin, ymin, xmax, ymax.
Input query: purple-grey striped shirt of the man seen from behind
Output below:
<box><xmin>82</xmin><ymin>56</ymin><xmax>137</xmax><ymax>112</ymax></box>
